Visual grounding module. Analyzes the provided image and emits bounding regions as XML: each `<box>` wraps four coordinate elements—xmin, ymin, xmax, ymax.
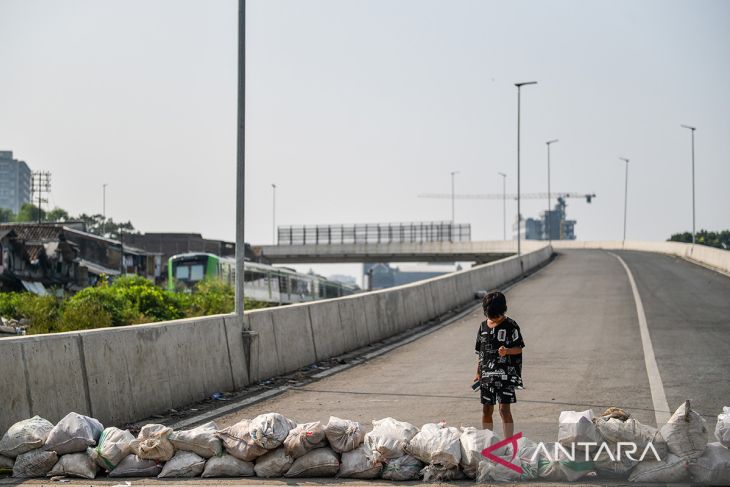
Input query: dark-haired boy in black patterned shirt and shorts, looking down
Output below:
<box><xmin>474</xmin><ymin>291</ymin><xmax>525</xmax><ymax>438</ymax></box>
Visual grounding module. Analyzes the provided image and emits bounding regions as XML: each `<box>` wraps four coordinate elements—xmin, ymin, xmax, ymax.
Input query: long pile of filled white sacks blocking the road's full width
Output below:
<box><xmin>0</xmin><ymin>401</ymin><xmax>730</xmax><ymax>485</ymax></box>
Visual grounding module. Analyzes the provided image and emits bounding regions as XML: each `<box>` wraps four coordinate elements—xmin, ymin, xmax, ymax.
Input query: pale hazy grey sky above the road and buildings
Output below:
<box><xmin>0</xmin><ymin>0</ymin><xmax>730</xmax><ymax>282</ymax></box>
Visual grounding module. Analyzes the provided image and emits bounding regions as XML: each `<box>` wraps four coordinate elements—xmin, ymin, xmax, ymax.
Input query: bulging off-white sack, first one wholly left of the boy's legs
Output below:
<box><xmin>405</xmin><ymin>423</ymin><xmax>461</xmax><ymax>469</ymax></box>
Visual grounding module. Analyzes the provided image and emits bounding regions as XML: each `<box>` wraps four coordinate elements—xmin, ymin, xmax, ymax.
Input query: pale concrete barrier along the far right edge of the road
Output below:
<box><xmin>553</xmin><ymin>240</ymin><xmax>730</xmax><ymax>274</ymax></box>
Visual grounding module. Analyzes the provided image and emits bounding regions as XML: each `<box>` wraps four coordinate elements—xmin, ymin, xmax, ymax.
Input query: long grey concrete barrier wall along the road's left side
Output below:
<box><xmin>0</xmin><ymin>246</ymin><xmax>552</xmax><ymax>434</ymax></box>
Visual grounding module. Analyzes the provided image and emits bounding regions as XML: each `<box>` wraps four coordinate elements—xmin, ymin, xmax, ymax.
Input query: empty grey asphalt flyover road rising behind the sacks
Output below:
<box><xmin>217</xmin><ymin>250</ymin><xmax>730</xmax><ymax>441</ymax></box>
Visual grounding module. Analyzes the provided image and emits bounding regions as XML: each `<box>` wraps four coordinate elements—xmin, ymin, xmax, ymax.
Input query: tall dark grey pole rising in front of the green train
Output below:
<box><xmin>235</xmin><ymin>0</ymin><xmax>246</xmax><ymax>317</ymax></box>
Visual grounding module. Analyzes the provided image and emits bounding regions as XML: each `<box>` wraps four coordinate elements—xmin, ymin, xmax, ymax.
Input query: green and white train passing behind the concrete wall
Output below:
<box><xmin>167</xmin><ymin>252</ymin><xmax>359</xmax><ymax>304</ymax></box>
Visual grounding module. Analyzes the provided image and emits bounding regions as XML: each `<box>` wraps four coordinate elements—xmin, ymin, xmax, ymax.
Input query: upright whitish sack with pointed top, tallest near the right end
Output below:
<box><xmin>659</xmin><ymin>401</ymin><xmax>707</xmax><ymax>460</ymax></box>
